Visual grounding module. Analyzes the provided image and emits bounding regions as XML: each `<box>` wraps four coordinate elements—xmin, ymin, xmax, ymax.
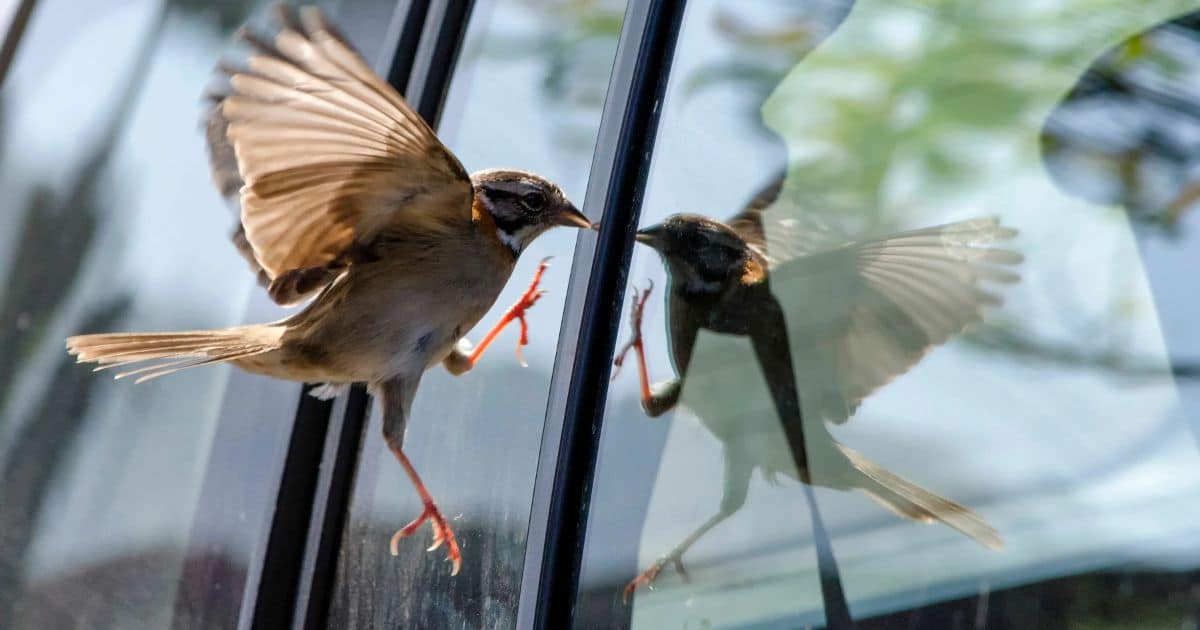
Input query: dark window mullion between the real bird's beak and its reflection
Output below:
<box><xmin>517</xmin><ymin>0</ymin><xmax>686</xmax><ymax>629</ymax></box>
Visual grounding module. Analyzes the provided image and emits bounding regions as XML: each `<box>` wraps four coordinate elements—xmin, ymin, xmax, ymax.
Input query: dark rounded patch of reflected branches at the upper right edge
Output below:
<box><xmin>1042</xmin><ymin>12</ymin><xmax>1200</xmax><ymax>229</ymax></box>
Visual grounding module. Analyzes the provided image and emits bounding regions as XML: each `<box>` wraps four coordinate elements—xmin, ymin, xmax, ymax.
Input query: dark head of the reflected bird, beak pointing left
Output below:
<box><xmin>637</xmin><ymin>215</ymin><xmax>754</xmax><ymax>293</ymax></box>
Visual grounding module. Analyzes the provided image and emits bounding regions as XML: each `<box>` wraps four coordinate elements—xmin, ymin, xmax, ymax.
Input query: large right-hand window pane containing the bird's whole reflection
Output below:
<box><xmin>577</xmin><ymin>0</ymin><xmax>1200</xmax><ymax>628</ymax></box>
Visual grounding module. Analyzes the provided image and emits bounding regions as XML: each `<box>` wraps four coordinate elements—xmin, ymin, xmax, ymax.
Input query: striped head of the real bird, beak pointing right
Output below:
<box><xmin>470</xmin><ymin>169</ymin><xmax>595</xmax><ymax>256</ymax></box>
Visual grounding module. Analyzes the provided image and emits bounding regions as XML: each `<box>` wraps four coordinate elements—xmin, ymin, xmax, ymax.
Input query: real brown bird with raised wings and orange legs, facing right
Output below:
<box><xmin>66</xmin><ymin>5</ymin><xmax>595</xmax><ymax>574</ymax></box>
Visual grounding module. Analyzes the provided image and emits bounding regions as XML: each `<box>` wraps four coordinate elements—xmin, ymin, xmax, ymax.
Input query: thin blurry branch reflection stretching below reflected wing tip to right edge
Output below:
<box><xmin>962</xmin><ymin>326</ymin><xmax>1200</xmax><ymax>378</ymax></box>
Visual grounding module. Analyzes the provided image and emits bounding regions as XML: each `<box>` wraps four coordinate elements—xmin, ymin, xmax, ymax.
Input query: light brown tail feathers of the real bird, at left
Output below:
<box><xmin>67</xmin><ymin>324</ymin><xmax>284</xmax><ymax>383</ymax></box>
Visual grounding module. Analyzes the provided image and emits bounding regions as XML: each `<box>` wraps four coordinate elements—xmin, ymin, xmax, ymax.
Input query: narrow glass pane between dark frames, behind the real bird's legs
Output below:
<box><xmin>330</xmin><ymin>0</ymin><xmax>624</xmax><ymax>628</ymax></box>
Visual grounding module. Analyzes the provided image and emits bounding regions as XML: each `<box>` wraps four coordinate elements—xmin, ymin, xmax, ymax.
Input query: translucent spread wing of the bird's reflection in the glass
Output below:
<box><xmin>770</xmin><ymin>218</ymin><xmax>1022</xmax><ymax>422</ymax></box>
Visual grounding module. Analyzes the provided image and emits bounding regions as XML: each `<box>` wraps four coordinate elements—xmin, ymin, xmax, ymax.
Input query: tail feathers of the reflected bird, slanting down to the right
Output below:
<box><xmin>838</xmin><ymin>444</ymin><xmax>1004</xmax><ymax>550</ymax></box>
